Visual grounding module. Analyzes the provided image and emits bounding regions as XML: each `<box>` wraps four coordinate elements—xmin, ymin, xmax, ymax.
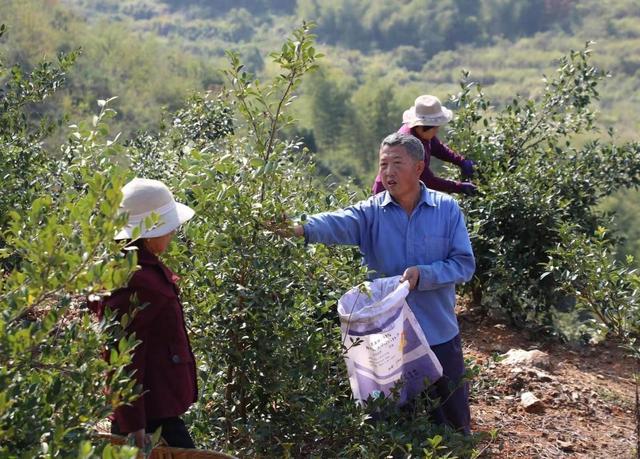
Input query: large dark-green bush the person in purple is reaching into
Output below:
<box><xmin>442</xmin><ymin>44</ymin><xmax>640</xmax><ymax>334</ymax></box>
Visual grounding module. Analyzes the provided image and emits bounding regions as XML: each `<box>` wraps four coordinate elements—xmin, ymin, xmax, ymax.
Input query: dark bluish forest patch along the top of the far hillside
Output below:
<box><xmin>297</xmin><ymin>0</ymin><xmax>572</xmax><ymax>56</ymax></box>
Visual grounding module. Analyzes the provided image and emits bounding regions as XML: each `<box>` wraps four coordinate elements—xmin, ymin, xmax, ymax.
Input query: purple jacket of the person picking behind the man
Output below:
<box><xmin>371</xmin><ymin>124</ymin><xmax>464</xmax><ymax>194</ymax></box>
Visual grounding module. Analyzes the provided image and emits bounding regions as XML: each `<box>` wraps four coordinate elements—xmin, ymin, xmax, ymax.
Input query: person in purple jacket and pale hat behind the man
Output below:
<box><xmin>371</xmin><ymin>94</ymin><xmax>477</xmax><ymax>196</ymax></box>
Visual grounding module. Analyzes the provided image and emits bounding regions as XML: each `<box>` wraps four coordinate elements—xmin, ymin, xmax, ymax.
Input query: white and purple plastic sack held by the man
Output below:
<box><xmin>338</xmin><ymin>276</ymin><xmax>442</xmax><ymax>404</ymax></box>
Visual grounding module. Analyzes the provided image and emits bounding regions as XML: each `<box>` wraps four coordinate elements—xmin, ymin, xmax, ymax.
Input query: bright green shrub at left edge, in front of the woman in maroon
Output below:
<box><xmin>0</xmin><ymin>106</ymin><xmax>141</xmax><ymax>458</ymax></box>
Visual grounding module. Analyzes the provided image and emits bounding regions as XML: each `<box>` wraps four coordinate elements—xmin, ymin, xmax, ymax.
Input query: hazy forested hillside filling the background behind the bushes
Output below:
<box><xmin>0</xmin><ymin>0</ymin><xmax>640</xmax><ymax>254</ymax></box>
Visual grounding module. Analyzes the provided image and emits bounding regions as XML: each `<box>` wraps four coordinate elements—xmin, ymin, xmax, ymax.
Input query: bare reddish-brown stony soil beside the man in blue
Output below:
<box><xmin>458</xmin><ymin>307</ymin><xmax>638</xmax><ymax>459</ymax></box>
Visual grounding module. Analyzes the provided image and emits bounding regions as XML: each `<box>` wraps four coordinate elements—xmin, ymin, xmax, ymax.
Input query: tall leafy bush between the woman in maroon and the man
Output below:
<box><xmin>124</xmin><ymin>26</ymin><xmax>476</xmax><ymax>457</ymax></box>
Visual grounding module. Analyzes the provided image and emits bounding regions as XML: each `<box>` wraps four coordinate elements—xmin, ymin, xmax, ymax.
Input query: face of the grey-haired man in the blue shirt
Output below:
<box><xmin>378</xmin><ymin>145</ymin><xmax>424</xmax><ymax>199</ymax></box>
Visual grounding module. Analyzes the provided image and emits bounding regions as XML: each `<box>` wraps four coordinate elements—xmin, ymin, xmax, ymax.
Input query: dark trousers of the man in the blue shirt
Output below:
<box><xmin>429</xmin><ymin>335</ymin><xmax>471</xmax><ymax>434</ymax></box>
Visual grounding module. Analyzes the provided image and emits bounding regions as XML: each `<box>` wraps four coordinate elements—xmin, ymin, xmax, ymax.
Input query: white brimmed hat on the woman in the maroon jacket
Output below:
<box><xmin>115</xmin><ymin>178</ymin><xmax>195</xmax><ymax>239</ymax></box>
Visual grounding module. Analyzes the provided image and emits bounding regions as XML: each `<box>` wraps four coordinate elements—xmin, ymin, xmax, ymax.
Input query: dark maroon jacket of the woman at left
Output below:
<box><xmin>104</xmin><ymin>248</ymin><xmax>198</xmax><ymax>433</ymax></box>
